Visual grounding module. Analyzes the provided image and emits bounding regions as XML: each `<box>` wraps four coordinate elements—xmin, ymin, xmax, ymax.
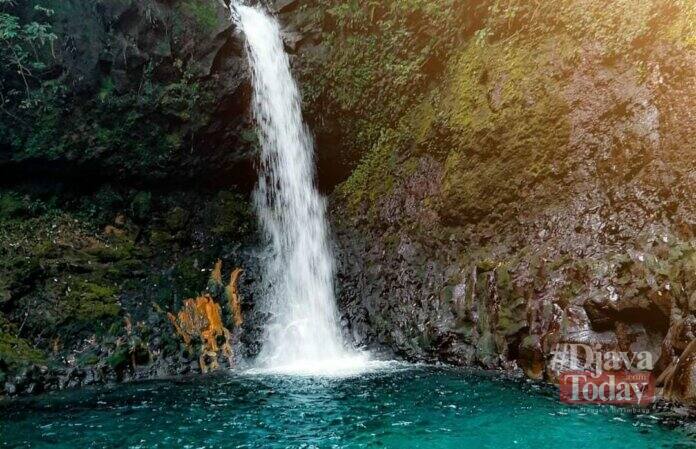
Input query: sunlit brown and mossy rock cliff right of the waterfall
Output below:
<box><xmin>294</xmin><ymin>0</ymin><xmax>696</xmax><ymax>400</ymax></box>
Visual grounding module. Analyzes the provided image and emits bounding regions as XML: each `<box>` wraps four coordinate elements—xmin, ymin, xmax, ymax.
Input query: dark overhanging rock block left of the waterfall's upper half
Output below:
<box><xmin>0</xmin><ymin>0</ymin><xmax>255</xmax><ymax>189</ymax></box>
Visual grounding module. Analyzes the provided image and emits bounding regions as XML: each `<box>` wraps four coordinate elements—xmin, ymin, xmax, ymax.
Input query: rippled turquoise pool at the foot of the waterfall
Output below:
<box><xmin>0</xmin><ymin>365</ymin><xmax>696</xmax><ymax>449</ymax></box>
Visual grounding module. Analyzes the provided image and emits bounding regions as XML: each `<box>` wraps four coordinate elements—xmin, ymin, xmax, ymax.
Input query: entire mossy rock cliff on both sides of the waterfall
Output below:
<box><xmin>0</xmin><ymin>0</ymin><xmax>696</xmax><ymax>401</ymax></box>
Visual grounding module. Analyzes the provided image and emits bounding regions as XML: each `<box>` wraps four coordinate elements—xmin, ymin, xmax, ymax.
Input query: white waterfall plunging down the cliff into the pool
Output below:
<box><xmin>232</xmin><ymin>4</ymin><xmax>366</xmax><ymax>374</ymax></box>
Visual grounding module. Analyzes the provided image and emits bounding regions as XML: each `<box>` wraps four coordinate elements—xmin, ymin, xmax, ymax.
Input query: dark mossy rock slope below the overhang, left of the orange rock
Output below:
<box><xmin>0</xmin><ymin>178</ymin><xmax>252</xmax><ymax>378</ymax></box>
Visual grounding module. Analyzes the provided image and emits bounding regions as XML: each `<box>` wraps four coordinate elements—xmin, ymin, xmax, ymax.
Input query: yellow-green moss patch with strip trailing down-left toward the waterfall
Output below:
<box><xmin>338</xmin><ymin>36</ymin><xmax>570</xmax><ymax>221</ymax></box>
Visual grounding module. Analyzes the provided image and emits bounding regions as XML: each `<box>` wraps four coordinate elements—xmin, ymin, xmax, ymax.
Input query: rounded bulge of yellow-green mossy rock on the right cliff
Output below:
<box><xmin>441</xmin><ymin>41</ymin><xmax>570</xmax><ymax>220</ymax></box>
